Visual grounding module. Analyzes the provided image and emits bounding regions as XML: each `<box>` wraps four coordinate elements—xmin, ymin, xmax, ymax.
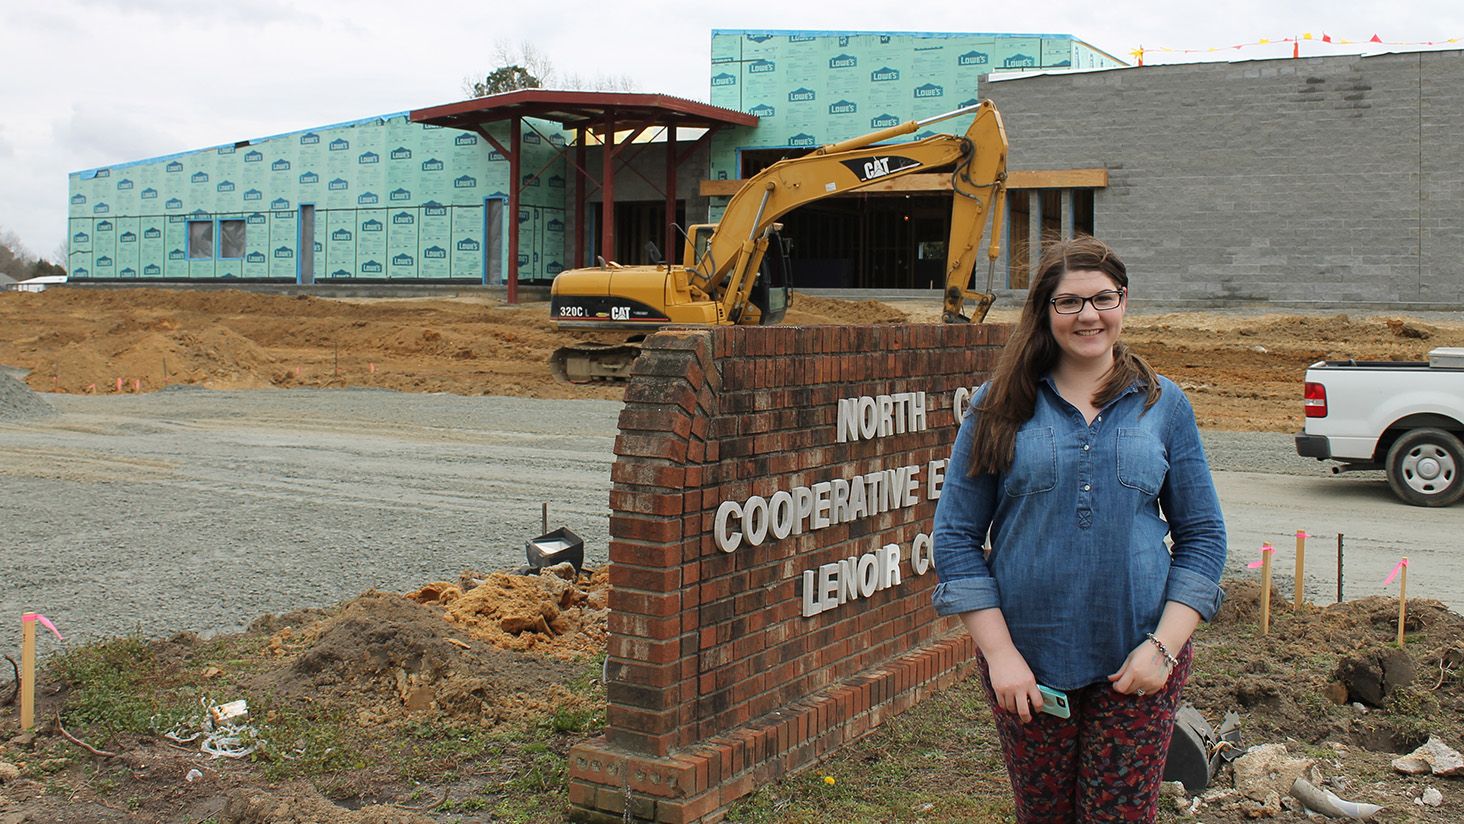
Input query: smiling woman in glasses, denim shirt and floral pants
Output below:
<box><xmin>934</xmin><ymin>237</ymin><xmax>1225</xmax><ymax>823</ymax></box>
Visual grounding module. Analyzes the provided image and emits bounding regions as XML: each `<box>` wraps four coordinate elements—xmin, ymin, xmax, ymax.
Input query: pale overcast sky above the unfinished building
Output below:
<box><xmin>0</xmin><ymin>0</ymin><xmax>1464</xmax><ymax>264</ymax></box>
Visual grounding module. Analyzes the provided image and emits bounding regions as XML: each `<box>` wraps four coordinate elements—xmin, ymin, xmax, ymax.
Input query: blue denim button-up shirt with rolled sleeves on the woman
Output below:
<box><xmin>931</xmin><ymin>378</ymin><xmax>1225</xmax><ymax>689</ymax></box>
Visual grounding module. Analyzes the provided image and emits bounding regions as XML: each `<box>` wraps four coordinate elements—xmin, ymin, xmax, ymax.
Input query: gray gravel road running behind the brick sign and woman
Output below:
<box><xmin>0</xmin><ymin>389</ymin><xmax>1446</xmax><ymax>647</ymax></box>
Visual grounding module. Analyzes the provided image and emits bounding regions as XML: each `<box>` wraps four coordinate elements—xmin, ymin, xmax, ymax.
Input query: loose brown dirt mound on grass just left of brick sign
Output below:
<box><xmin>258</xmin><ymin>591</ymin><xmax>583</xmax><ymax>724</ymax></box>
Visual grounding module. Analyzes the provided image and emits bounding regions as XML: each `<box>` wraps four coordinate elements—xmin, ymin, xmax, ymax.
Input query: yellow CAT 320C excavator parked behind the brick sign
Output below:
<box><xmin>549</xmin><ymin>101</ymin><xmax>1007</xmax><ymax>383</ymax></box>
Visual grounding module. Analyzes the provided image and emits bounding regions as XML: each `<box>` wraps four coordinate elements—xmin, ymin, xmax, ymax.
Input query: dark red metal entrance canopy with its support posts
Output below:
<box><xmin>410</xmin><ymin>89</ymin><xmax>757</xmax><ymax>303</ymax></box>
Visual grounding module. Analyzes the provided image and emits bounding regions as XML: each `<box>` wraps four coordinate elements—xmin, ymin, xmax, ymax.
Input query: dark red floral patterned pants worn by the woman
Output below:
<box><xmin>976</xmin><ymin>644</ymin><xmax>1195</xmax><ymax>824</ymax></box>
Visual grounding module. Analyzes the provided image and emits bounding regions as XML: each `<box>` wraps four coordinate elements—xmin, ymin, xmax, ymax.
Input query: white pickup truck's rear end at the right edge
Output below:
<box><xmin>1296</xmin><ymin>348</ymin><xmax>1464</xmax><ymax>506</ymax></box>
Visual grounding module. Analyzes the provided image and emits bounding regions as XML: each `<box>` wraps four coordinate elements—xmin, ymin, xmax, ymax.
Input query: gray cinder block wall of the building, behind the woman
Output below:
<box><xmin>984</xmin><ymin>51</ymin><xmax>1464</xmax><ymax>309</ymax></box>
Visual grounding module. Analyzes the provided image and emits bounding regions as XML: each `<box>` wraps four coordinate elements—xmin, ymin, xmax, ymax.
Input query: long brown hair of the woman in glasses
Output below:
<box><xmin>971</xmin><ymin>236</ymin><xmax>1159</xmax><ymax>476</ymax></box>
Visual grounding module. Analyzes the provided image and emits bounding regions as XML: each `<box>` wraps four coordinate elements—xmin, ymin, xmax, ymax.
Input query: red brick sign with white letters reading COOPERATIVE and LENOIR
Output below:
<box><xmin>569</xmin><ymin>325</ymin><xmax>1007</xmax><ymax>821</ymax></box>
